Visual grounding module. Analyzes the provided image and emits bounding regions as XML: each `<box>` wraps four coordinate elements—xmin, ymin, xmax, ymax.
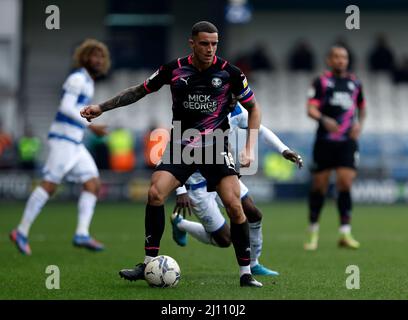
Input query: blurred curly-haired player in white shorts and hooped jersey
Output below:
<box><xmin>10</xmin><ymin>39</ymin><xmax>110</xmax><ymax>255</ymax></box>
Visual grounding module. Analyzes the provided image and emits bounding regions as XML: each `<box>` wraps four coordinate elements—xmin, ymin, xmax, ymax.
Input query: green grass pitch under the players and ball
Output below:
<box><xmin>0</xmin><ymin>202</ymin><xmax>408</xmax><ymax>300</ymax></box>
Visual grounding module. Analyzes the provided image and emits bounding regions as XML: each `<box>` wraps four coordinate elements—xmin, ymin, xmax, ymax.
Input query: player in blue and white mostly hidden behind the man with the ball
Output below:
<box><xmin>171</xmin><ymin>103</ymin><xmax>303</xmax><ymax>276</ymax></box>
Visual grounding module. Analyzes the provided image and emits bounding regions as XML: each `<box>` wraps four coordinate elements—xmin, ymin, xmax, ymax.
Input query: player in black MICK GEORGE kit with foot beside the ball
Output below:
<box><xmin>81</xmin><ymin>21</ymin><xmax>262</xmax><ymax>287</ymax></box>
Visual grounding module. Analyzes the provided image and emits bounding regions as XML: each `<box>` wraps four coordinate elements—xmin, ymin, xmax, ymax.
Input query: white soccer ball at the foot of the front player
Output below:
<box><xmin>144</xmin><ymin>255</ymin><xmax>180</xmax><ymax>288</ymax></box>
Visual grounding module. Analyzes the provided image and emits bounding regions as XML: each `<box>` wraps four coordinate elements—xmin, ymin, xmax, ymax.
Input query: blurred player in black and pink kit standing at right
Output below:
<box><xmin>304</xmin><ymin>46</ymin><xmax>366</xmax><ymax>250</ymax></box>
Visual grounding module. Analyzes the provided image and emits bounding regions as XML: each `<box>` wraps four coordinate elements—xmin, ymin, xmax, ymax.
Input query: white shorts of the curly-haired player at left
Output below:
<box><xmin>43</xmin><ymin>139</ymin><xmax>99</xmax><ymax>184</ymax></box>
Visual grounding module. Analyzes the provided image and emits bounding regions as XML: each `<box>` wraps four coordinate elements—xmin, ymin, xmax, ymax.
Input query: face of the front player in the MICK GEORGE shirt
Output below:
<box><xmin>190</xmin><ymin>32</ymin><xmax>218</xmax><ymax>64</ymax></box>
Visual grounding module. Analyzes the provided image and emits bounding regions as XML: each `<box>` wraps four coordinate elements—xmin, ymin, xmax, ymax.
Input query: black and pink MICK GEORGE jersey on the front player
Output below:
<box><xmin>144</xmin><ymin>55</ymin><xmax>254</xmax><ymax>145</ymax></box>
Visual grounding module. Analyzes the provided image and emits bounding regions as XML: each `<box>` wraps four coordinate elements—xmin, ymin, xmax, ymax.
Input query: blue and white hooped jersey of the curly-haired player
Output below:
<box><xmin>48</xmin><ymin>68</ymin><xmax>94</xmax><ymax>144</ymax></box>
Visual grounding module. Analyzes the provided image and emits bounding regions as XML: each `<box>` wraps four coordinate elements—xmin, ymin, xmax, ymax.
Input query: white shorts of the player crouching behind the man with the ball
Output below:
<box><xmin>188</xmin><ymin>181</ymin><xmax>248</xmax><ymax>233</ymax></box>
